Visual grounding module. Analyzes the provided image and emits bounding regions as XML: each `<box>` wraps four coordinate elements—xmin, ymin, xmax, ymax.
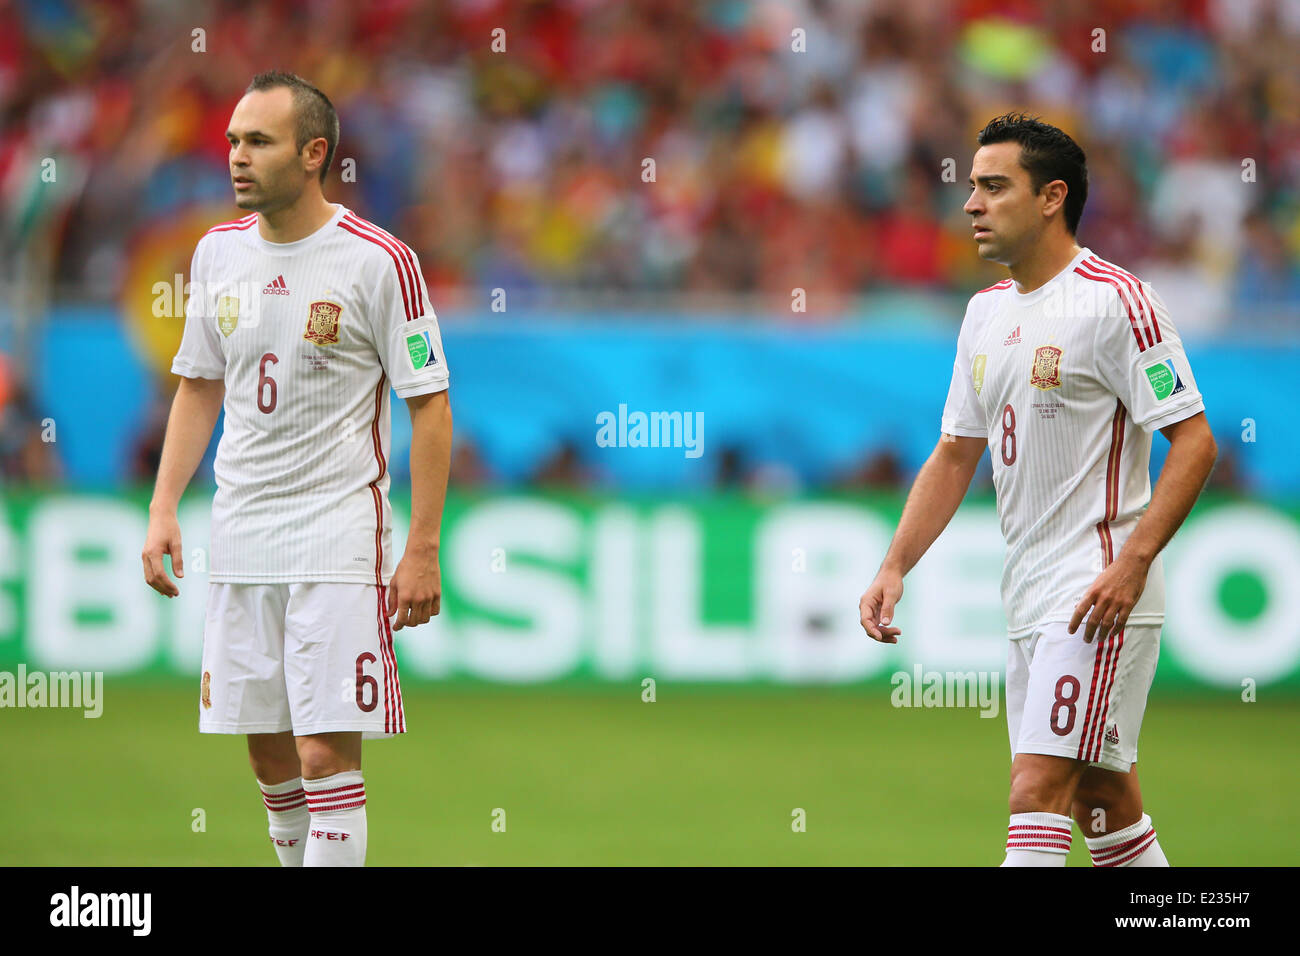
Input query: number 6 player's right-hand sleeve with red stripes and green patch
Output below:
<box><xmin>371</xmin><ymin>250</ymin><xmax>449</xmax><ymax>398</ymax></box>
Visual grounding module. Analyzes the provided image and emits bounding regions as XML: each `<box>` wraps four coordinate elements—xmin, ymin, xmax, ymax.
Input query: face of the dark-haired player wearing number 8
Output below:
<box><xmin>963</xmin><ymin>143</ymin><xmax>1045</xmax><ymax>265</ymax></box>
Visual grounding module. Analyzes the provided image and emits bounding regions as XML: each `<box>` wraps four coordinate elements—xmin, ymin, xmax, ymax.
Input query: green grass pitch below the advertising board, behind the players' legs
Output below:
<box><xmin>0</xmin><ymin>682</ymin><xmax>1300</xmax><ymax>866</ymax></box>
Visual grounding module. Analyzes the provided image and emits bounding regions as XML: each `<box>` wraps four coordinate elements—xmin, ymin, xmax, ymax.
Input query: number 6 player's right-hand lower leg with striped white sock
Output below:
<box><xmin>298</xmin><ymin>731</ymin><xmax>365</xmax><ymax>866</ymax></box>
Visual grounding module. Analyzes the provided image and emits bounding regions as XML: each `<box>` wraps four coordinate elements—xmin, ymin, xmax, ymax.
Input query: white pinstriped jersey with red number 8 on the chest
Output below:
<box><xmin>943</xmin><ymin>248</ymin><xmax>1205</xmax><ymax>639</ymax></box>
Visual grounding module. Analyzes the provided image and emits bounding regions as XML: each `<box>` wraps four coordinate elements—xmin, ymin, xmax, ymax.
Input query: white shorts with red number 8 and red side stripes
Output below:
<box><xmin>1006</xmin><ymin>623</ymin><xmax>1160</xmax><ymax>774</ymax></box>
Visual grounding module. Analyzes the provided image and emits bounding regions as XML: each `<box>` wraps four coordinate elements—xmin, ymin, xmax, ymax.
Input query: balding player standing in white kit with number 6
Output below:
<box><xmin>142</xmin><ymin>72</ymin><xmax>451</xmax><ymax>866</ymax></box>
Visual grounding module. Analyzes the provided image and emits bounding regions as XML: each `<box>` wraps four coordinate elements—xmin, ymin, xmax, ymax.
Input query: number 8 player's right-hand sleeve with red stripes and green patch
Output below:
<box><xmin>1096</xmin><ymin>282</ymin><xmax>1205</xmax><ymax>432</ymax></box>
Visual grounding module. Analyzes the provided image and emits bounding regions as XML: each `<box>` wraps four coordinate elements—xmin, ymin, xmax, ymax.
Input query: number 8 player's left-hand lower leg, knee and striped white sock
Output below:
<box><xmin>1002</xmin><ymin>753</ymin><xmax>1088</xmax><ymax>866</ymax></box>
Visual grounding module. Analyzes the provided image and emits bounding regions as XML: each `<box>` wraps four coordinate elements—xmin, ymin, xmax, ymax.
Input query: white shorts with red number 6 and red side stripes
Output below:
<box><xmin>199</xmin><ymin>581</ymin><xmax>406</xmax><ymax>739</ymax></box>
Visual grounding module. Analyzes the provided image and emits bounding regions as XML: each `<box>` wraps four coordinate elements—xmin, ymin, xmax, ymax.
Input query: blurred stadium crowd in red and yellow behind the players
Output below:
<box><xmin>0</xmin><ymin>0</ymin><xmax>1300</xmax><ymax>489</ymax></box>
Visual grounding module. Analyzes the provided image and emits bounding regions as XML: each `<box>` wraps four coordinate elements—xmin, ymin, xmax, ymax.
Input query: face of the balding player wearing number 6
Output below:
<box><xmin>226</xmin><ymin>87</ymin><xmax>316</xmax><ymax>212</ymax></box>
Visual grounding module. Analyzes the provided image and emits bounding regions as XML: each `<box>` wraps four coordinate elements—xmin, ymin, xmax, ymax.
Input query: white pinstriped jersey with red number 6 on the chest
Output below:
<box><xmin>172</xmin><ymin>206</ymin><xmax>447</xmax><ymax>584</ymax></box>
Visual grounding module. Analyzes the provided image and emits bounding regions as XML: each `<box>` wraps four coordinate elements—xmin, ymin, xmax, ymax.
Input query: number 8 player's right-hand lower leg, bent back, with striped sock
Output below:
<box><xmin>1073</xmin><ymin>763</ymin><xmax>1169</xmax><ymax>866</ymax></box>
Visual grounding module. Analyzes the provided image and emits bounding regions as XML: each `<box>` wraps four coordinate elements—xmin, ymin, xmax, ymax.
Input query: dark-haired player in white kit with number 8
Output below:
<box><xmin>859</xmin><ymin>113</ymin><xmax>1217</xmax><ymax>866</ymax></box>
